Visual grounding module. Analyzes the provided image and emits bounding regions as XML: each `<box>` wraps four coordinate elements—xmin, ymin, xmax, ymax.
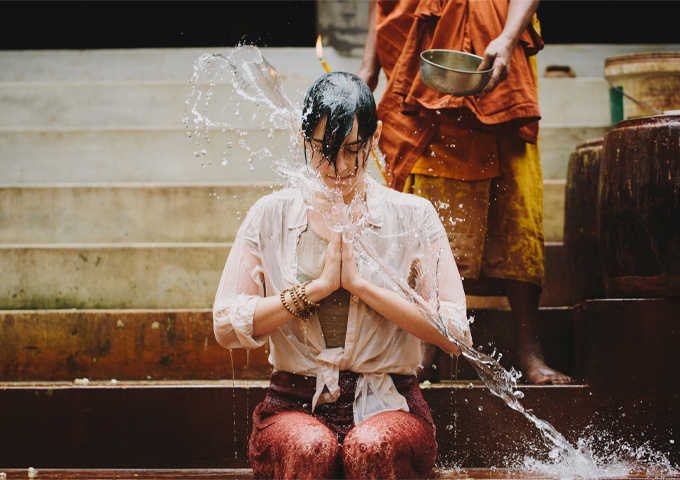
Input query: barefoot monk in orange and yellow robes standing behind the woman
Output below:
<box><xmin>358</xmin><ymin>0</ymin><xmax>571</xmax><ymax>384</ymax></box>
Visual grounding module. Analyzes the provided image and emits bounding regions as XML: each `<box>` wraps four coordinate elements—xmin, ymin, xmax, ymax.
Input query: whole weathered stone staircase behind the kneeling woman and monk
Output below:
<box><xmin>0</xmin><ymin>46</ymin><xmax>670</xmax><ymax>468</ymax></box>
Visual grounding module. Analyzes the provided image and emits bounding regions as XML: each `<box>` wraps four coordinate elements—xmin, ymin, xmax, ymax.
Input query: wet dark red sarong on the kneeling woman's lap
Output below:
<box><xmin>248</xmin><ymin>371</ymin><xmax>437</xmax><ymax>479</ymax></box>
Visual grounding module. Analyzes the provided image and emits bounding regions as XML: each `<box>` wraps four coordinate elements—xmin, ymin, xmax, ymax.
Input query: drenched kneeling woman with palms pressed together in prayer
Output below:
<box><xmin>214</xmin><ymin>72</ymin><xmax>471</xmax><ymax>478</ymax></box>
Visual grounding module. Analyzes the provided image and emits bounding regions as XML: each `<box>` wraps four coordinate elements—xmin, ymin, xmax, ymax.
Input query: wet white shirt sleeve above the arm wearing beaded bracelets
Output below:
<box><xmin>213</xmin><ymin>207</ymin><xmax>269</xmax><ymax>350</ymax></box>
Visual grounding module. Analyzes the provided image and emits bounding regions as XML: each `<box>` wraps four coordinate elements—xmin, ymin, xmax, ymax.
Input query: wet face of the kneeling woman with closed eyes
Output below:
<box><xmin>306</xmin><ymin>117</ymin><xmax>382</xmax><ymax>201</ymax></box>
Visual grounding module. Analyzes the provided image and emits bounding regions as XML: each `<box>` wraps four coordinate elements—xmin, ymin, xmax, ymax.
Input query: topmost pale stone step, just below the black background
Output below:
<box><xmin>5</xmin><ymin>43</ymin><xmax>680</xmax><ymax>81</ymax></box>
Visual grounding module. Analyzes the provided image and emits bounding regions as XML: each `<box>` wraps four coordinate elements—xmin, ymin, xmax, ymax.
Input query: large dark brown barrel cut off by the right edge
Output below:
<box><xmin>597</xmin><ymin>115</ymin><xmax>680</xmax><ymax>298</ymax></box>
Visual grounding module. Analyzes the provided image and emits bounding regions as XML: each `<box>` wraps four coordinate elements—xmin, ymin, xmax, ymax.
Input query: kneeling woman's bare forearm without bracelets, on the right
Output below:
<box><xmin>351</xmin><ymin>280</ymin><xmax>458</xmax><ymax>353</ymax></box>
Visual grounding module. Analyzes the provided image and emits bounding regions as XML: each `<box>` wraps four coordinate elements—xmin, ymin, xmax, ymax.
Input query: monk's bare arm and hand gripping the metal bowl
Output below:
<box><xmin>479</xmin><ymin>0</ymin><xmax>539</xmax><ymax>95</ymax></box>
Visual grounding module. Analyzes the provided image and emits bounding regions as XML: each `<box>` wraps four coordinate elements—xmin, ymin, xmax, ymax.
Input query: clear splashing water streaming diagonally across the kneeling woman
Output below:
<box><xmin>184</xmin><ymin>46</ymin><xmax>680</xmax><ymax>478</ymax></box>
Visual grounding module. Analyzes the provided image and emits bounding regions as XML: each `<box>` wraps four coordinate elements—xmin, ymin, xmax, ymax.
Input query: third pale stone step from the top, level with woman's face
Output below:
<box><xmin>0</xmin><ymin>124</ymin><xmax>608</xmax><ymax>185</ymax></box>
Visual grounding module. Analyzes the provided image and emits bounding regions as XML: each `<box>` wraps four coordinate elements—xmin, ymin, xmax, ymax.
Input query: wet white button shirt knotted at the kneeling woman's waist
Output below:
<box><xmin>213</xmin><ymin>181</ymin><xmax>471</xmax><ymax>424</ymax></box>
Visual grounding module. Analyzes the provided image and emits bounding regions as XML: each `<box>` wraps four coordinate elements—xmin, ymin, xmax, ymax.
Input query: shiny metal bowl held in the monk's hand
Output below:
<box><xmin>420</xmin><ymin>50</ymin><xmax>493</xmax><ymax>97</ymax></box>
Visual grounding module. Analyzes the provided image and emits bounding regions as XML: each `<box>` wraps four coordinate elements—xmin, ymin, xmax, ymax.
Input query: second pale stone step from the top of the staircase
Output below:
<box><xmin>0</xmin><ymin>77</ymin><xmax>611</xmax><ymax>129</ymax></box>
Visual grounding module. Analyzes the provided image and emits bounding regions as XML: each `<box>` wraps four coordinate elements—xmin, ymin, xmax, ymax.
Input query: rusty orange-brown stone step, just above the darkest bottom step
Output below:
<box><xmin>0</xmin><ymin>307</ymin><xmax>574</xmax><ymax>382</ymax></box>
